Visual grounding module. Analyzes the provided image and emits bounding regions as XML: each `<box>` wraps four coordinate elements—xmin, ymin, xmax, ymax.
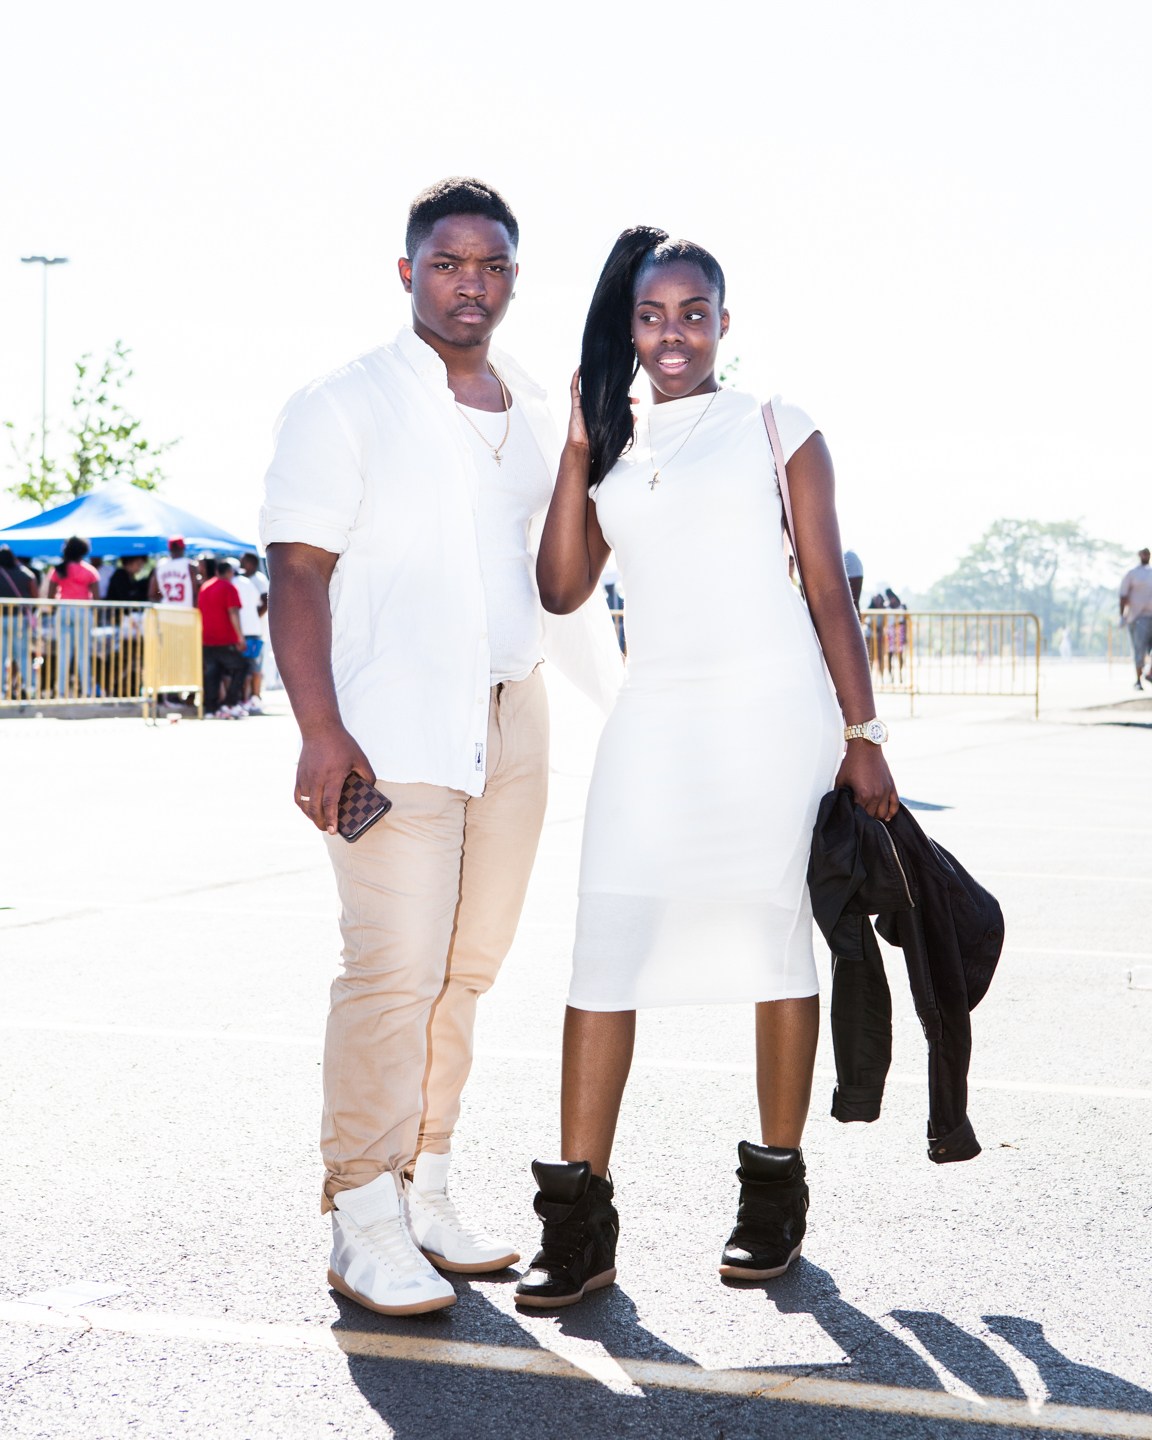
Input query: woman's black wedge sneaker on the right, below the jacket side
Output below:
<box><xmin>720</xmin><ymin>1140</ymin><xmax>808</xmax><ymax>1280</ymax></box>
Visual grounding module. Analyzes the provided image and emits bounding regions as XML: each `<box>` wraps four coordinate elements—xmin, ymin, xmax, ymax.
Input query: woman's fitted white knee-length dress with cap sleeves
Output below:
<box><xmin>569</xmin><ymin>390</ymin><xmax>842</xmax><ymax>1011</ymax></box>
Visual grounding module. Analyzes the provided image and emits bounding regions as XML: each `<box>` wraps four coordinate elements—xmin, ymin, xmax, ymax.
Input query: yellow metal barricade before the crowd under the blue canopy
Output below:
<box><xmin>0</xmin><ymin>600</ymin><xmax>203</xmax><ymax>719</ymax></box>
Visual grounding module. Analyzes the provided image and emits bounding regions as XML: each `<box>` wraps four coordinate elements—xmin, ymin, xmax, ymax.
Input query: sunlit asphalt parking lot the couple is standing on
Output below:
<box><xmin>0</xmin><ymin>668</ymin><xmax>1152</xmax><ymax>1440</ymax></box>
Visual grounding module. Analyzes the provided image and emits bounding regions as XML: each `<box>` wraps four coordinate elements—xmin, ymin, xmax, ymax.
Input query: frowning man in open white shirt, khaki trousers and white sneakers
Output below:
<box><xmin>261</xmin><ymin>179</ymin><xmax>621</xmax><ymax>1315</ymax></box>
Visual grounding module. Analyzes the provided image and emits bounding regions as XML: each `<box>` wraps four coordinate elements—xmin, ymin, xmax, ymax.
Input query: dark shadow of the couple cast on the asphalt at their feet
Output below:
<box><xmin>333</xmin><ymin>1260</ymin><xmax>1152</xmax><ymax>1440</ymax></box>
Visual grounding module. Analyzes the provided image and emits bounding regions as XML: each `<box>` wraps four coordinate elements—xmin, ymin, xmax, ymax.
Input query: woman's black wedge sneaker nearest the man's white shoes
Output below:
<box><xmin>516</xmin><ymin>1161</ymin><xmax>621</xmax><ymax>1310</ymax></box>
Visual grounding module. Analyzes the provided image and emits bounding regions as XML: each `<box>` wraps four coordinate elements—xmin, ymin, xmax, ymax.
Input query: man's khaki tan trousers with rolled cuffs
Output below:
<box><xmin>320</xmin><ymin>670</ymin><xmax>549</xmax><ymax>1210</ymax></box>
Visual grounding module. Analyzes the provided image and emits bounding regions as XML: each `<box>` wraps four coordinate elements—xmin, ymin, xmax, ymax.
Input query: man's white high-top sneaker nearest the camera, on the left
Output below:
<box><xmin>328</xmin><ymin>1171</ymin><xmax>456</xmax><ymax>1315</ymax></box>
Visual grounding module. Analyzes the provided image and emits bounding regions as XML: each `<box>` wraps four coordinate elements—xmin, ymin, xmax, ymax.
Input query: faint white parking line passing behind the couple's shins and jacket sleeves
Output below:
<box><xmin>0</xmin><ymin>1018</ymin><xmax>1152</xmax><ymax>1100</ymax></box>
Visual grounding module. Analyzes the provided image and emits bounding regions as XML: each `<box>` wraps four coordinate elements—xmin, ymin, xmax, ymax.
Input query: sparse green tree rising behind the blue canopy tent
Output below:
<box><xmin>6</xmin><ymin>340</ymin><xmax>179</xmax><ymax>510</ymax></box>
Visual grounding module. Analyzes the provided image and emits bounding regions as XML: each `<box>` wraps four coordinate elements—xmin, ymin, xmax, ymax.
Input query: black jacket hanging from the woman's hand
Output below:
<box><xmin>808</xmin><ymin>788</ymin><xmax>1004</xmax><ymax>1165</ymax></box>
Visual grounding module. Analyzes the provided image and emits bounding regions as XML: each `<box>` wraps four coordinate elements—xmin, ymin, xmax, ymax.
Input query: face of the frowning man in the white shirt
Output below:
<box><xmin>399</xmin><ymin>215</ymin><xmax>517</xmax><ymax>357</ymax></box>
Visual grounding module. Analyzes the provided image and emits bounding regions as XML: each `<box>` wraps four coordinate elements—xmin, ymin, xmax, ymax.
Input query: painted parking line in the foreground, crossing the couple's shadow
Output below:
<box><xmin>0</xmin><ymin>1300</ymin><xmax>1152</xmax><ymax>1440</ymax></box>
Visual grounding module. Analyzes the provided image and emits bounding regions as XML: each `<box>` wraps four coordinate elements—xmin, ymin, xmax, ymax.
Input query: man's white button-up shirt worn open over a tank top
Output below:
<box><xmin>261</xmin><ymin>327</ymin><xmax>622</xmax><ymax>795</ymax></box>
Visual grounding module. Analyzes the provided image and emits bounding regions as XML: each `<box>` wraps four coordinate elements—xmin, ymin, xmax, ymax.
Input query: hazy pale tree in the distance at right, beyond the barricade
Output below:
<box><xmin>927</xmin><ymin>520</ymin><xmax>1125</xmax><ymax>654</ymax></box>
